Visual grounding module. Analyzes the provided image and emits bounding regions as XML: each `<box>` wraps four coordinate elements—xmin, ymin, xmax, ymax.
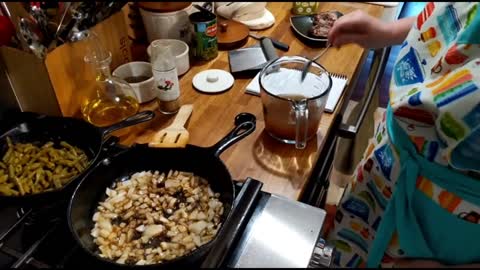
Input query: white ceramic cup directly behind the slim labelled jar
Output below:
<box><xmin>147</xmin><ymin>39</ymin><xmax>190</xmax><ymax>76</ymax></box>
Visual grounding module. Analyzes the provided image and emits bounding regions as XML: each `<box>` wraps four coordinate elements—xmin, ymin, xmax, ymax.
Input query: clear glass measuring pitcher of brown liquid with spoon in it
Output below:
<box><xmin>259</xmin><ymin>56</ymin><xmax>332</xmax><ymax>149</ymax></box>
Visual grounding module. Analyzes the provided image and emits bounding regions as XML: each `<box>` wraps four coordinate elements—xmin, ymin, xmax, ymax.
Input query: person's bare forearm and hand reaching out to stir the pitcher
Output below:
<box><xmin>328</xmin><ymin>10</ymin><xmax>415</xmax><ymax>48</ymax></box>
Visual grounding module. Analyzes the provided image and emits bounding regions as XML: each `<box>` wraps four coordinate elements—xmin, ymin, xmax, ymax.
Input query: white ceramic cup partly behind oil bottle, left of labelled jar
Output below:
<box><xmin>112</xmin><ymin>62</ymin><xmax>157</xmax><ymax>103</ymax></box>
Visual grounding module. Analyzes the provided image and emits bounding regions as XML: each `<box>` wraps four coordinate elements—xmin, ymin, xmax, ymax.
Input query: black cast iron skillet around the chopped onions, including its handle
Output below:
<box><xmin>67</xmin><ymin>113</ymin><xmax>256</xmax><ymax>268</ymax></box>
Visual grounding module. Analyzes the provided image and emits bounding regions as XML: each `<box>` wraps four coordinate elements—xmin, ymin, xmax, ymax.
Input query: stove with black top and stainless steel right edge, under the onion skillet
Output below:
<box><xmin>0</xmin><ymin>179</ymin><xmax>333</xmax><ymax>269</ymax></box>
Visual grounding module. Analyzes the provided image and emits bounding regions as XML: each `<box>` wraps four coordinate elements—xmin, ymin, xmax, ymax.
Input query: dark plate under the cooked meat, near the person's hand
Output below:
<box><xmin>290</xmin><ymin>11</ymin><xmax>343</xmax><ymax>46</ymax></box>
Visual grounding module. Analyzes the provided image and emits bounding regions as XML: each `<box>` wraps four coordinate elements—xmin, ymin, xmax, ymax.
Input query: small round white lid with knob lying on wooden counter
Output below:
<box><xmin>192</xmin><ymin>69</ymin><xmax>235</xmax><ymax>93</ymax></box>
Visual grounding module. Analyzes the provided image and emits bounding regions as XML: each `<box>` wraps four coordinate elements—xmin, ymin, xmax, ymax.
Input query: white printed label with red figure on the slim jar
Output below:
<box><xmin>153</xmin><ymin>68</ymin><xmax>180</xmax><ymax>101</ymax></box>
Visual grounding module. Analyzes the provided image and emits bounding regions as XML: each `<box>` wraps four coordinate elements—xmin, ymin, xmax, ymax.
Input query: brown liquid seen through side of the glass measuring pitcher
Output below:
<box><xmin>263</xmin><ymin>95</ymin><xmax>324</xmax><ymax>141</ymax></box>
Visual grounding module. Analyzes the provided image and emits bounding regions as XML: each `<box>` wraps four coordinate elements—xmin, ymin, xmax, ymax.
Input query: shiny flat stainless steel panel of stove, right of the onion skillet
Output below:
<box><xmin>228</xmin><ymin>194</ymin><xmax>325</xmax><ymax>268</ymax></box>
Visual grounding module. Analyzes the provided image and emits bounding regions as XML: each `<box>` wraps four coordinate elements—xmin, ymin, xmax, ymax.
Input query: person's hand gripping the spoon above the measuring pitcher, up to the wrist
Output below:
<box><xmin>328</xmin><ymin>10</ymin><xmax>389</xmax><ymax>48</ymax></box>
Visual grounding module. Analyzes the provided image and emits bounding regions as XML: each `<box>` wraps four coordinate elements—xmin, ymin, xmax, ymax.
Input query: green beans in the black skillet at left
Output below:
<box><xmin>0</xmin><ymin>137</ymin><xmax>89</xmax><ymax>196</ymax></box>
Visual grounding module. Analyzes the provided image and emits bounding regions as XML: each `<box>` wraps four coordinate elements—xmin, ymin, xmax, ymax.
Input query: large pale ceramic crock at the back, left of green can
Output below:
<box><xmin>140</xmin><ymin>5</ymin><xmax>193</xmax><ymax>42</ymax></box>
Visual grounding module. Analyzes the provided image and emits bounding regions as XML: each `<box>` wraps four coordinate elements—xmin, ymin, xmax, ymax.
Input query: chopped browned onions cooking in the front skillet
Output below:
<box><xmin>91</xmin><ymin>171</ymin><xmax>224</xmax><ymax>265</ymax></box>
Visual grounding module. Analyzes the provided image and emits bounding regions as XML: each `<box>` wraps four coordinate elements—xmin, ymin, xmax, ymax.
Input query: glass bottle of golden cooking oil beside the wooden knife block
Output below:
<box><xmin>81</xmin><ymin>32</ymin><xmax>140</xmax><ymax>127</ymax></box>
